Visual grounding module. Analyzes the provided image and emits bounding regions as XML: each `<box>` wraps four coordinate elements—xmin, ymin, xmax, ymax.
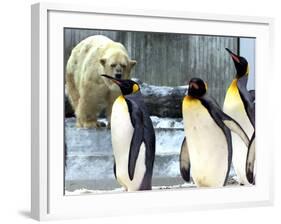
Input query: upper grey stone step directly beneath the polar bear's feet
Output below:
<box><xmin>65</xmin><ymin>118</ymin><xmax>184</xmax><ymax>156</ymax></box>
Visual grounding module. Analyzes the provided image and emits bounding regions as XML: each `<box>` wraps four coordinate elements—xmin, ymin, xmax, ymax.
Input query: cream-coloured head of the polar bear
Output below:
<box><xmin>100</xmin><ymin>44</ymin><xmax>137</xmax><ymax>87</ymax></box>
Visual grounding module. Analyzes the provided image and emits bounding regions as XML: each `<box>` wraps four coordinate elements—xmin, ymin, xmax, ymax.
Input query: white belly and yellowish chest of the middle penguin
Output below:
<box><xmin>183</xmin><ymin>102</ymin><xmax>228</xmax><ymax>187</ymax></box>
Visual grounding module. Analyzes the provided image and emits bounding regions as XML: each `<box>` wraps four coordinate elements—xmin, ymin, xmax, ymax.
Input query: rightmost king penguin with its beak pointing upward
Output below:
<box><xmin>223</xmin><ymin>48</ymin><xmax>255</xmax><ymax>185</ymax></box>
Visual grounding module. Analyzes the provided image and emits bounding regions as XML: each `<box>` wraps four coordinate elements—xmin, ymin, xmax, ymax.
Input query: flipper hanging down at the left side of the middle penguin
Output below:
<box><xmin>180</xmin><ymin>137</ymin><xmax>190</xmax><ymax>182</ymax></box>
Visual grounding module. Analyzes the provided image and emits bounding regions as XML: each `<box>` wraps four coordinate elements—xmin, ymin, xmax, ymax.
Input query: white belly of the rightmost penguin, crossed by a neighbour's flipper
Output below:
<box><xmin>223</xmin><ymin>92</ymin><xmax>254</xmax><ymax>185</ymax></box>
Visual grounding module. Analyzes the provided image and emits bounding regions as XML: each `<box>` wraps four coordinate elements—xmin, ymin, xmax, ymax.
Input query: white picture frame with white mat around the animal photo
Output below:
<box><xmin>31</xmin><ymin>3</ymin><xmax>274</xmax><ymax>220</ymax></box>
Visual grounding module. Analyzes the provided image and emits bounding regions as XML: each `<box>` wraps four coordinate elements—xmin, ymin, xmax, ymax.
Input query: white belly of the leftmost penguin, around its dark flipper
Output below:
<box><xmin>111</xmin><ymin>96</ymin><xmax>146</xmax><ymax>191</ymax></box>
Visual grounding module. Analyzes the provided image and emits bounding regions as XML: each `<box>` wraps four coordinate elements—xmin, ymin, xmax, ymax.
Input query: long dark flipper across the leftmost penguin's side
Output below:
<box><xmin>125</xmin><ymin>97</ymin><xmax>144</xmax><ymax>180</ymax></box>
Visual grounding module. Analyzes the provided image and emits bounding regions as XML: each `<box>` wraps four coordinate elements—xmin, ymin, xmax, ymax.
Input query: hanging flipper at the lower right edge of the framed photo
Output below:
<box><xmin>246</xmin><ymin>132</ymin><xmax>256</xmax><ymax>184</ymax></box>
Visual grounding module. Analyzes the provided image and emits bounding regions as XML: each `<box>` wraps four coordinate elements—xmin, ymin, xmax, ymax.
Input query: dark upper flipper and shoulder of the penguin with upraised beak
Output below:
<box><xmin>237</xmin><ymin>75</ymin><xmax>255</xmax><ymax>127</ymax></box>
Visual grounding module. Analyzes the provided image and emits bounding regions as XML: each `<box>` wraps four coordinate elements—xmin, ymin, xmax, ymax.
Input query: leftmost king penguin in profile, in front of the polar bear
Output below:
<box><xmin>102</xmin><ymin>75</ymin><xmax>155</xmax><ymax>191</ymax></box>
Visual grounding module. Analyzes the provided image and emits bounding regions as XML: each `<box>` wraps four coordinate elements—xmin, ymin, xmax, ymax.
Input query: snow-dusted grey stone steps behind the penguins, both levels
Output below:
<box><xmin>65</xmin><ymin>117</ymin><xmax>235</xmax><ymax>189</ymax></box>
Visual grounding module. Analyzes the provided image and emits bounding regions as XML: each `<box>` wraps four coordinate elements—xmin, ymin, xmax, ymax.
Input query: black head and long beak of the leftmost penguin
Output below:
<box><xmin>102</xmin><ymin>75</ymin><xmax>140</xmax><ymax>96</ymax></box>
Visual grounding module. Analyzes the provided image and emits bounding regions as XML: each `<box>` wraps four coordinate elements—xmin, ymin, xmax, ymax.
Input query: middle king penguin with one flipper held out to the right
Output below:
<box><xmin>180</xmin><ymin>78</ymin><xmax>249</xmax><ymax>187</ymax></box>
